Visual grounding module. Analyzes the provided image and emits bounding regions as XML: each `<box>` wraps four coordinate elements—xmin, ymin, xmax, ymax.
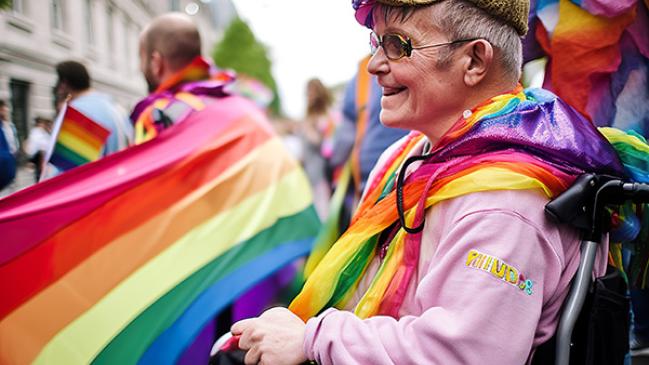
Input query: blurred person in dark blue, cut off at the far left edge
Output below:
<box><xmin>0</xmin><ymin>100</ymin><xmax>18</xmax><ymax>193</ymax></box>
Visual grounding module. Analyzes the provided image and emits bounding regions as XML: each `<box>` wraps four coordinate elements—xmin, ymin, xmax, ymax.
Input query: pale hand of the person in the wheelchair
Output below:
<box><xmin>230</xmin><ymin>307</ymin><xmax>307</xmax><ymax>365</ymax></box>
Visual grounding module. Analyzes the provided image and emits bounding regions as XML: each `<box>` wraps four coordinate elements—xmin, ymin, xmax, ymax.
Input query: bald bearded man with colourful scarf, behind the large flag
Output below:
<box><xmin>131</xmin><ymin>13</ymin><xmax>234</xmax><ymax>144</ymax></box>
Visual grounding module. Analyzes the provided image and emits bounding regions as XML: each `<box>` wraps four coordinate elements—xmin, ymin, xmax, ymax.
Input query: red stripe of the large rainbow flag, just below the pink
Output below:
<box><xmin>0</xmin><ymin>114</ymin><xmax>270</xmax><ymax>318</ymax></box>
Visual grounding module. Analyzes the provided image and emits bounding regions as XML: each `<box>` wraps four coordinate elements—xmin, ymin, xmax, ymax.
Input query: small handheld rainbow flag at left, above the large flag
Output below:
<box><xmin>46</xmin><ymin>105</ymin><xmax>110</xmax><ymax>171</ymax></box>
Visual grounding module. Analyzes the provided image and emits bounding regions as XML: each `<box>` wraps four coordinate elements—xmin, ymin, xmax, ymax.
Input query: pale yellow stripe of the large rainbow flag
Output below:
<box><xmin>34</xmin><ymin>151</ymin><xmax>312</xmax><ymax>364</ymax></box>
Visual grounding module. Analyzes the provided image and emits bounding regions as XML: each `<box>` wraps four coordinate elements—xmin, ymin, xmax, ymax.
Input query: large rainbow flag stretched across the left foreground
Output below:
<box><xmin>0</xmin><ymin>97</ymin><xmax>319</xmax><ymax>364</ymax></box>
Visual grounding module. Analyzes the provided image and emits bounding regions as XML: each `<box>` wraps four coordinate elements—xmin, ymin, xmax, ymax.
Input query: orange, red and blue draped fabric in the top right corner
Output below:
<box><xmin>525</xmin><ymin>0</ymin><xmax>649</xmax><ymax>131</ymax></box>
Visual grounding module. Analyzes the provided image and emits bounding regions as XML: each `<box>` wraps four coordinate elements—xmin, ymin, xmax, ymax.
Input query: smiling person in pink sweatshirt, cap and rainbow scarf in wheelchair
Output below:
<box><xmin>231</xmin><ymin>0</ymin><xmax>623</xmax><ymax>365</ymax></box>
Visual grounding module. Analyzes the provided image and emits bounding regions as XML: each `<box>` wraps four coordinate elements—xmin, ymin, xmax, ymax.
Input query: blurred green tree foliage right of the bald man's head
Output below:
<box><xmin>212</xmin><ymin>18</ymin><xmax>281</xmax><ymax>115</ymax></box>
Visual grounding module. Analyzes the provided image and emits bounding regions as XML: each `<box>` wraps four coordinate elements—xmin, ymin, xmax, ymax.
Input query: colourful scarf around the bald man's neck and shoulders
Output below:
<box><xmin>131</xmin><ymin>56</ymin><xmax>235</xmax><ymax>144</ymax></box>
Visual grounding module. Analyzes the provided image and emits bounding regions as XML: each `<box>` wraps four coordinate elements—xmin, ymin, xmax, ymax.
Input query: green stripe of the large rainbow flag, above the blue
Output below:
<box><xmin>93</xmin><ymin>207</ymin><xmax>320</xmax><ymax>364</ymax></box>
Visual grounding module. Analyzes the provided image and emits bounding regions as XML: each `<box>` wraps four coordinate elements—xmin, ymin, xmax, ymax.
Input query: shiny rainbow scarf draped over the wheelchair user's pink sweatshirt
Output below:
<box><xmin>290</xmin><ymin>87</ymin><xmax>623</xmax><ymax>320</ymax></box>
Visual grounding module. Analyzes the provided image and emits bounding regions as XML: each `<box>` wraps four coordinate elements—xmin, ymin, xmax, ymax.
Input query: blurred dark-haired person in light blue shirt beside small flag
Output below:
<box><xmin>55</xmin><ymin>61</ymin><xmax>133</xmax><ymax>156</ymax></box>
